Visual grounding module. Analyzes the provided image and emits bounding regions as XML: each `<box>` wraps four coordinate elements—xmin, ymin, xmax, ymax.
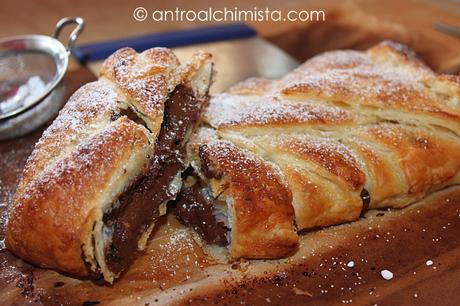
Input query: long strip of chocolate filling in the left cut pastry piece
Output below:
<box><xmin>103</xmin><ymin>85</ymin><xmax>205</xmax><ymax>273</ymax></box>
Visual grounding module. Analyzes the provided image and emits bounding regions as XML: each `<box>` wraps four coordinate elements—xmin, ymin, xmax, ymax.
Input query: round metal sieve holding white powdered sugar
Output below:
<box><xmin>0</xmin><ymin>17</ymin><xmax>84</xmax><ymax>140</ymax></box>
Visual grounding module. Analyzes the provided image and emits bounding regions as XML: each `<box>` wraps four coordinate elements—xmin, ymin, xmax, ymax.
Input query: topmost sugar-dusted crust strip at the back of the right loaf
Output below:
<box><xmin>279</xmin><ymin>44</ymin><xmax>445</xmax><ymax>111</ymax></box>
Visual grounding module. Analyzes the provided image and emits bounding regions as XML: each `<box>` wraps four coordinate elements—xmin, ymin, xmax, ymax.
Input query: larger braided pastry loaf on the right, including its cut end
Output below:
<box><xmin>176</xmin><ymin>42</ymin><xmax>460</xmax><ymax>258</ymax></box>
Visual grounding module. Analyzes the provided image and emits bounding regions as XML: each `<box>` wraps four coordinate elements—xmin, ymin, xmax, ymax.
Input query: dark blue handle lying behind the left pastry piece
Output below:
<box><xmin>73</xmin><ymin>23</ymin><xmax>257</xmax><ymax>63</ymax></box>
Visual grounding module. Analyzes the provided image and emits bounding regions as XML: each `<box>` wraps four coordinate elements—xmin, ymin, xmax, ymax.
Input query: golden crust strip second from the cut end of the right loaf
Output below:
<box><xmin>251</xmin><ymin>134</ymin><xmax>365</xmax><ymax>229</ymax></box>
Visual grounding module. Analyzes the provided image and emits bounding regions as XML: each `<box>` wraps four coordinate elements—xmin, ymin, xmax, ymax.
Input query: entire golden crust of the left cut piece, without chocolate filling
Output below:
<box><xmin>6</xmin><ymin>48</ymin><xmax>212</xmax><ymax>282</ymax></box>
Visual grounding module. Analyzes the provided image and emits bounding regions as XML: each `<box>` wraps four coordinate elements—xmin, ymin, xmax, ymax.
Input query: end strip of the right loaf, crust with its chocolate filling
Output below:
<box><xmin>175</xmin><ymin>140</ymin><xmax>298</xmax><ymax>259</ymax></box>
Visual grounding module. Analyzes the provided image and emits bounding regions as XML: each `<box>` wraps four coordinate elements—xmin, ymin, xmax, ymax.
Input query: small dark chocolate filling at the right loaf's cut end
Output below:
<box><xmin>174</xmin><ymin>183</ymin><xmax>228</xmax><ymax>246</ymax></box>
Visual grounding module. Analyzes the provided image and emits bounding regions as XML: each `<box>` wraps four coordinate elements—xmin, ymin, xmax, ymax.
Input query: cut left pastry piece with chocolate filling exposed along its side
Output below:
<box><xmin>6</xmin><ymin>48</ymin><xmax>212</xmax><ymax>282</ymax></box>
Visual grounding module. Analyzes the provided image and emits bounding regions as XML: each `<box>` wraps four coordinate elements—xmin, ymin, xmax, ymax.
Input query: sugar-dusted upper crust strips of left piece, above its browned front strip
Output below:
<box><xmin>17</xmin><ymin>48</ymin><xmax>212</xmax><ymax>195</ymax></box>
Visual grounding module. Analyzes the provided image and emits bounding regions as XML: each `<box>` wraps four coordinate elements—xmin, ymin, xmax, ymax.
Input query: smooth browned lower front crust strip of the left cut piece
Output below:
<box><xmin>6</xmin><ymin>117</ymin><xmax>150</xmax><ymax>275</ymax></box>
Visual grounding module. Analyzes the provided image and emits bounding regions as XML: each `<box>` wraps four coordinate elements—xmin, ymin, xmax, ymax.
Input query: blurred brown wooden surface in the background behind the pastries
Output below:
<box><xmin>0</xmin><ymin>0</ymin><xmax>460</xmax><ymax>71</ymax></box>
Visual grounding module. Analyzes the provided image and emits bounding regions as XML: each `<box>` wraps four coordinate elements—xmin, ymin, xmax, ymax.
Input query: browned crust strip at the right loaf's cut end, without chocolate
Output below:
<box><xmin>198</xmin><ymin>140</ymin><xmax>298</xmax><ymax>258</ymax></box>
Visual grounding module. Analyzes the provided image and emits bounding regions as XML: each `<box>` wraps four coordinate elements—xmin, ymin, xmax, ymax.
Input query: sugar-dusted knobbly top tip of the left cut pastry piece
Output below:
<box><xmin>100</xmin><ymin>48</ymin><xmax>210</xmax><ymax>124</ymax></box>
